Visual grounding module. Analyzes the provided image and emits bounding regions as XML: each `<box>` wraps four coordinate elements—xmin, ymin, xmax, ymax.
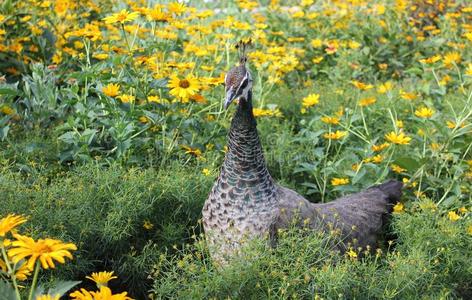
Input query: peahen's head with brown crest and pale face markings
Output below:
<box><xmin>224</xmin><ymin>41</ymin><xmax>252</xmax><ymax>109</ymax></box>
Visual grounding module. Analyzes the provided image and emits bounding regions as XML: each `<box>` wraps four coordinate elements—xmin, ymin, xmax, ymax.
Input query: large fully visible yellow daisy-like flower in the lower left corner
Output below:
<box><xmin>8</xmin><ymin>234</ymin><xmax>77</xmax><ymax>270</ymax></box>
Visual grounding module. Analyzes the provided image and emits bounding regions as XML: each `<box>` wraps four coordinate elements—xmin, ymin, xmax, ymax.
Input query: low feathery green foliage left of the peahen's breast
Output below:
<box><xmin>0</xmin><ymin>164</ymin><xmax>212</xmax><ymax>293</ymax></box>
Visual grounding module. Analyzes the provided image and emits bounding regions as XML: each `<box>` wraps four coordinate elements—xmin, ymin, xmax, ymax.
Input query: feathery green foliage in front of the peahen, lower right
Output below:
<box><xmin>153</xmin><ymin>202</ymin><xmax>472</xmax><ymax>299</ymax></box>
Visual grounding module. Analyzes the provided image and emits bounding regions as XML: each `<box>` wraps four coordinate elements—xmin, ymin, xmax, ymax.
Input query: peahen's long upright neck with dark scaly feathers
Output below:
<box><xmin>221</xmin><ymin>91</ymin><xmax>274</xmax><ymax>189</ymax></box>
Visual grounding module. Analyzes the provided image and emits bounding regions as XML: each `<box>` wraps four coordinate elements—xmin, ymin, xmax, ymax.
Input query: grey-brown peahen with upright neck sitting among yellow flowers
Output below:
<box><xmin>202</xmin><ymin>44</ymin><xmax>402</xmax><ymax>264</ymax></box>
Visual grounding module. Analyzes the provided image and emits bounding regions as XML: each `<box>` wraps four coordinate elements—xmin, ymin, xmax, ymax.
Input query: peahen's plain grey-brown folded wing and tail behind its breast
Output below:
<box><xmin>276</xmin><ymin>181</ymin><xmax>402</xmax><ymax>251</ymax></box>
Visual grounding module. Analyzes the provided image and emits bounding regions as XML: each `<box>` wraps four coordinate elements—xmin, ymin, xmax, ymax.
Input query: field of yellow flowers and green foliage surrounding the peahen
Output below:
<box><xmin>0</xmin><ymin>0</ymin><xmax>472</xmax><ymax>300</ymax></box>
